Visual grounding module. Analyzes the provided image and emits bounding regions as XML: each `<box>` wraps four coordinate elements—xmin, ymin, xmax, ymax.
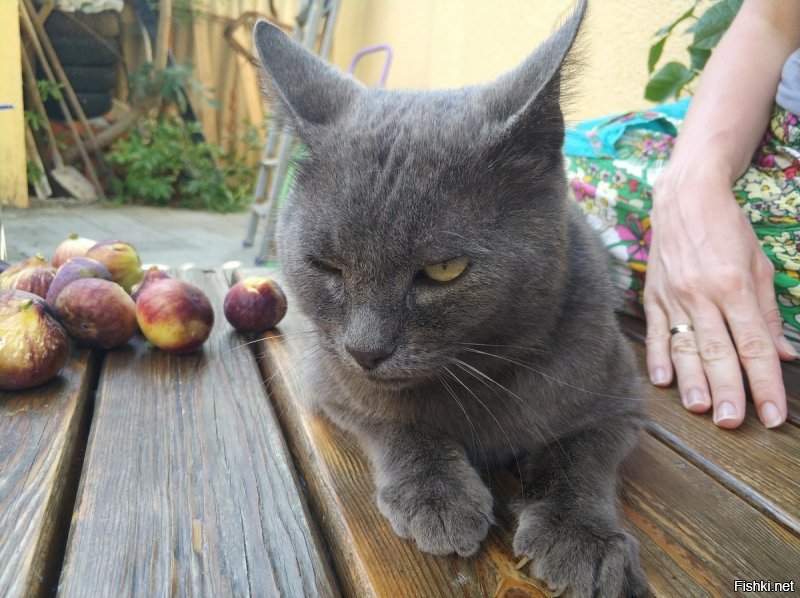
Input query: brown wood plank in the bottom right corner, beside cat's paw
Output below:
<box><xmin>622</xmin><ymin>435</ymin><xmax>800</xmax><ymax>596</ymax></box>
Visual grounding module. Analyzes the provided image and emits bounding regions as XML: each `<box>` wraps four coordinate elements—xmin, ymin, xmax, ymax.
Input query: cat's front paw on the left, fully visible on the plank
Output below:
<box><xmin>377</xmin><ymin>474</ymin><xmax>494</xmax><ymax>557</ymax></box>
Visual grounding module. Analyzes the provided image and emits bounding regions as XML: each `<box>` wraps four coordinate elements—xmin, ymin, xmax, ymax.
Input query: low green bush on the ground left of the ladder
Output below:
<box><xmin>108</xmin><ymin>114</ymin><xmax>254</xmax><ymax>212</ymax></box>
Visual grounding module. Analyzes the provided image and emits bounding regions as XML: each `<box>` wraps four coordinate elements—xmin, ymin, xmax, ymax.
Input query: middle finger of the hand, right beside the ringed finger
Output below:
<box><xmin>690</xmin><ymin>302</ymin><xmax>745</xmax><ymax>428</ymax></box>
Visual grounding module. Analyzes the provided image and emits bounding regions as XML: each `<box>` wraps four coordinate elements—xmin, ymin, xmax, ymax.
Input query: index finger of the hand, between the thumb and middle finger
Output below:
<box><xmin>725</xmin><ymin>302</ymin><xmax>786</xmax><ymax>428</ymax></box>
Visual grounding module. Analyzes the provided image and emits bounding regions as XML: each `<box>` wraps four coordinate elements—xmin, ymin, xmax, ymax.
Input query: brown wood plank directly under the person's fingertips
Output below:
<box><xmin>620</xmin><ymin>318</ymin><xmax>800</xmax><ymax>533</ymax></box>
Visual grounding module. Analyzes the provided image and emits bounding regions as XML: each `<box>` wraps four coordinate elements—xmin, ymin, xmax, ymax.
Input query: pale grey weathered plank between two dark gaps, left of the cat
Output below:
<box><xmin>59</xmin><ymin>271</ymin><xmax>338</xmax><ymax>596</ymax></box>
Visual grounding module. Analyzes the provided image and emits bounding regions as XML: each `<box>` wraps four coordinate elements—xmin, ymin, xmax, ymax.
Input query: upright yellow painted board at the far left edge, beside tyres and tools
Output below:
<box><xmin>0</xmin><ymin>0</ymin><xmax>28</xmax><ymax>208</ymax></box>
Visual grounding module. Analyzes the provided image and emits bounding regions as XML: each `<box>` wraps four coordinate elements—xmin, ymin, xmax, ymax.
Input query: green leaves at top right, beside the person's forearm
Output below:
<box><xmin>644</xmin><ymin>0</ymin><xmax>742</xmax><ymax>102</ymax></box>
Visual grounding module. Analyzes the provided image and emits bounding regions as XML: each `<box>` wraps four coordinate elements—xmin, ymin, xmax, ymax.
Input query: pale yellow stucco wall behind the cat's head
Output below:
<box><xmin>331</xmin><ymin>0</ymin><xmax>693</xmax><ymax>119</ymax></box>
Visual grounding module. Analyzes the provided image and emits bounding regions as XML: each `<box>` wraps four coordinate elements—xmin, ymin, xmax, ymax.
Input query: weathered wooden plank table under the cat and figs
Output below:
<box><xmin>0</xmin><ymin>271</ymin><xmax>800</xmax><ymax>597</ymax></box>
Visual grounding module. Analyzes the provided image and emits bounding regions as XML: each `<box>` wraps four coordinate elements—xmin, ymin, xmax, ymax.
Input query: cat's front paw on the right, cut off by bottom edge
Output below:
<box><xmin>514</xmin><ymin>501</ymin><xmax>649</xmax><ymax>598</ymax></box>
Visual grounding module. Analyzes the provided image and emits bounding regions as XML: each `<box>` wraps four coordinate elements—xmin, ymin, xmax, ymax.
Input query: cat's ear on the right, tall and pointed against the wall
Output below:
<box><xmin>482</xmin><ymin>0</ymin><xmax>587</xmax><ymax>151</ymax></box>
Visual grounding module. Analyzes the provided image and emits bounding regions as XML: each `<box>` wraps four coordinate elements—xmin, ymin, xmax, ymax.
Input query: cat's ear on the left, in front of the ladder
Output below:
<box><xmin>253</xmin><ymin>21</ymin><xmax>361</xmax><ymax>142</ymax></box>
